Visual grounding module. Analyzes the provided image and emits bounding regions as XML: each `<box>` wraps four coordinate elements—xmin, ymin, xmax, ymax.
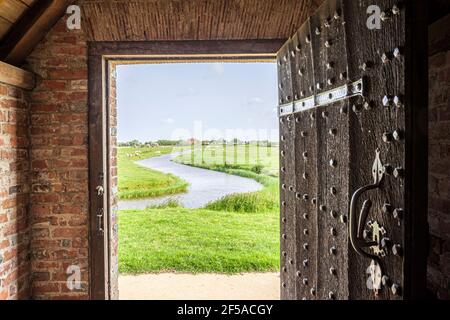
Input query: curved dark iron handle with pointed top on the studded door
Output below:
<box><xmin>349</xmin><ymin>150</ymin><xmax>385</xmax><ymax>266</ymax></box>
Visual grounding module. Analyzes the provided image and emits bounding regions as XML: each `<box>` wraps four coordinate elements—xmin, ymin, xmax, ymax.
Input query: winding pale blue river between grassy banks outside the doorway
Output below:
<box><xmin>119</xmin><ymin>153</ymin><xmax>263</xmax><ymax>210</ymax></box>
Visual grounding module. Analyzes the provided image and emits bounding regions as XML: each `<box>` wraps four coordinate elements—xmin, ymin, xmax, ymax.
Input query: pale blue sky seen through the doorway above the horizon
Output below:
<box><xmin>117</xmin><ymin>63</ymin><xmax>278</xmax><ymax>142</ymax></box>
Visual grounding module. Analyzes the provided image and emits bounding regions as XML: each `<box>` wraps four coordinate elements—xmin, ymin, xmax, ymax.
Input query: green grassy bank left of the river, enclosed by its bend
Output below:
<box><xmin>118</xmin><ymin>147</ymin><xmax>188</xmax><ymax>199</ymax></box>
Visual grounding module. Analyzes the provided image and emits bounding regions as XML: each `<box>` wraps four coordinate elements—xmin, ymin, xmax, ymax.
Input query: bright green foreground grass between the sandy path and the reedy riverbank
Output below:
<box><xmin>119</xmin><ymin>208</ymin><xmax>279</xmax><ymax>274</ymax></box>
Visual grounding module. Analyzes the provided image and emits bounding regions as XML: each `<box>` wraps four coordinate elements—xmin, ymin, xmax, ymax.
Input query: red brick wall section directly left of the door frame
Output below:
<box><xmin>26</xmin><ymin>18</ymin><xmax>89</xmax><ymax>299</ymax></box>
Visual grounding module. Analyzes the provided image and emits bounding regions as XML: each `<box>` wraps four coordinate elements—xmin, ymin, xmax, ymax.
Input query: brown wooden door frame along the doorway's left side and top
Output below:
<box><xmin>88</xmin><ymin>39</ymin><xmax>287</xmax><ymax>300</ymax></box>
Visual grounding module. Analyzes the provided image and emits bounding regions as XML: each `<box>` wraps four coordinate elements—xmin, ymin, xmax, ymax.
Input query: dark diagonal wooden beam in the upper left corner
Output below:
<box><xmin>0</xmin><ymin>0</ymin><xmax>74</xmax><ymax>66</ymax></box>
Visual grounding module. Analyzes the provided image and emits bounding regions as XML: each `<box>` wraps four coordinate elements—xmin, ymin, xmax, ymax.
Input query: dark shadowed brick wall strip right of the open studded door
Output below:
<box><xmin>428</xmin><ymin>17</ymin><xmax>450</xmax><ymax>299</ymax></box>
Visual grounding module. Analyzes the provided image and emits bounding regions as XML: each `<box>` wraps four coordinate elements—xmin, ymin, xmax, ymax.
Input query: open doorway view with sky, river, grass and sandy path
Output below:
<box><xmin>112</xmin><ymin>62</ymin><xmax>279</xmax><ymax>300</ymax></box>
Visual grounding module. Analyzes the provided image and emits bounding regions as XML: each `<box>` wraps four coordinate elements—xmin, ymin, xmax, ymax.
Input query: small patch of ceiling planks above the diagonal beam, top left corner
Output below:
<box><xmin>0</xmin><ymin>0</ymin><xmax>37</xmax><ymax>39</ymax></box>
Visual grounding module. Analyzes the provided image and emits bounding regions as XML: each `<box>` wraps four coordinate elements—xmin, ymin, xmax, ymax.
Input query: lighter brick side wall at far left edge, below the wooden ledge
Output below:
<box><xmin>0</xmin><ymin>84</ymin><xmax>30</xmax><ymax>300</ymax></box>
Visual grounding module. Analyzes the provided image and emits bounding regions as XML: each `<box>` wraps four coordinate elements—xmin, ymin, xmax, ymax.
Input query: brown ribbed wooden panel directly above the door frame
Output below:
<box><xmin>79</xmin><ymin>0</ymin><xmax>323</xmax><ymax>41</ymax></box>
